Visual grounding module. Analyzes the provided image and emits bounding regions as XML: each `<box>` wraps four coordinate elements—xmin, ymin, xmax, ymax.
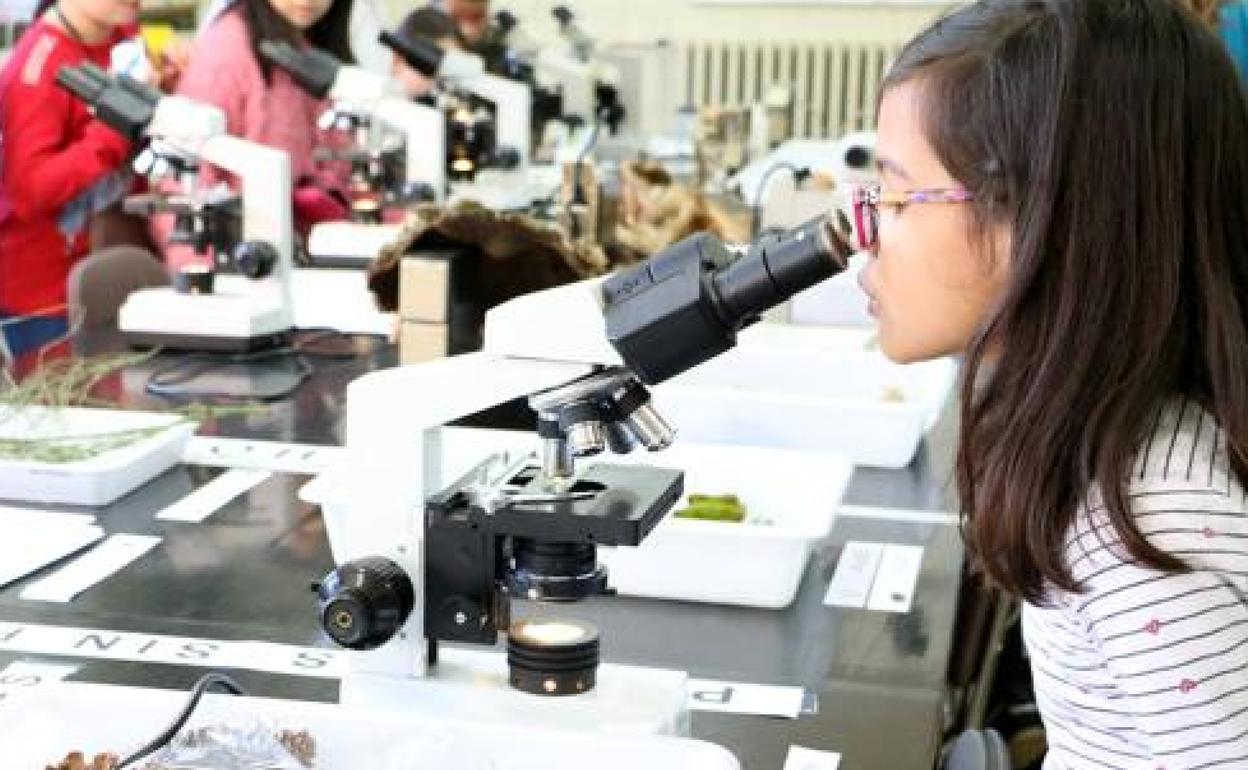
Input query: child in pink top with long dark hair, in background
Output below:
<box><xmin>152</xmin><ymin>0</ymin><xmax>354</xmax><ymax>268</ymax></box>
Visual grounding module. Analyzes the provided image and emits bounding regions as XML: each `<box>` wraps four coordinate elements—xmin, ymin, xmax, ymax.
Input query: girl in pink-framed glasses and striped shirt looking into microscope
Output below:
<box><xmin>855</xmin><ymin>0</ymin><xmax>1248</xmax><ymax>770</ymax></box>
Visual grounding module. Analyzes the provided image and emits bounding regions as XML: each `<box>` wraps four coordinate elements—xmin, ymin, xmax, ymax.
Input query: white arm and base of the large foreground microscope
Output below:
<box><xmin>324</xmin><ymin>285</ymin><xmax>688</xmax><ymax>733</ymax></box>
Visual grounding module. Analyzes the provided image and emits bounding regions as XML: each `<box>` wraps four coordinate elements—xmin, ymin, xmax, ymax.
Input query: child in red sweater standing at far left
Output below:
<box><xmin>0</xmin><ymin>0</ymin><xmax>139</xmax><ymax>357</ymax></box>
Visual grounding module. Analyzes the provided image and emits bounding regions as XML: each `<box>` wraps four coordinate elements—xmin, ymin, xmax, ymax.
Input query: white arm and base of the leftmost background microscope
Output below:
<box><xmin>117</xmin><ymin>97</ymin><xmax>295</xmax><ymax>351</ymax></box>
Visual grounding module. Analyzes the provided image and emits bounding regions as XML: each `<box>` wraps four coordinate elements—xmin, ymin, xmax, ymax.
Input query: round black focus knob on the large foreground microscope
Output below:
<box><xmin>316</xmin><ymin>557</ymin><xmax>416</xmax><ymax>650</ymax></box>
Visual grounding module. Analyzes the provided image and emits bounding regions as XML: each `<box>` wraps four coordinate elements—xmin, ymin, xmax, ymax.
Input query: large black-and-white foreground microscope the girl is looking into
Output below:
<box><xmin>310</xmin><ymin>213</ymin><xmax>849</xmax><ymax>733</ymax></box>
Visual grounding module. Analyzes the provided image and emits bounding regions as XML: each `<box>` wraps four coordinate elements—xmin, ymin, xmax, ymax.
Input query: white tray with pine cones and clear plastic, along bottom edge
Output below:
<box><xmin>0</xmin><ymin>683</ymin><xmax>740</xmax><ymax>770</ymax></box>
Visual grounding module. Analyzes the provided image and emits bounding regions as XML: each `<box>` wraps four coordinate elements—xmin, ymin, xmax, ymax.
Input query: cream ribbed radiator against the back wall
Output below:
<box><xmin>680</xmin><ymin>40</ymin><xmax>901</xmax><ymax>139</ymax></box>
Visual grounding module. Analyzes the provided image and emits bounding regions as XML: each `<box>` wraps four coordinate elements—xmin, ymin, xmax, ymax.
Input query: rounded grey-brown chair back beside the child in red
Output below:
<box><xmin>66</xmin><ymin>246</ymin><xmax>168</xmax><ymax>329</ymax></box>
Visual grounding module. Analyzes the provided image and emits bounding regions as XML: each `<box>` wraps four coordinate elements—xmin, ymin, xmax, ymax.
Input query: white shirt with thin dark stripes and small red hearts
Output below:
<box><xmin>1023</xmin><ymin>401</ymin><xmax>1248</xmax><ymax>770</ymax></box>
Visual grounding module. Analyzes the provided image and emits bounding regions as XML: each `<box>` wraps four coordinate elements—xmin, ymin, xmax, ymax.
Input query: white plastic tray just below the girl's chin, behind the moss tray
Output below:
<box><xmin>653</xmin><ymin>344</ymin><xmax>957</xmax><ymax>468</ymax></box>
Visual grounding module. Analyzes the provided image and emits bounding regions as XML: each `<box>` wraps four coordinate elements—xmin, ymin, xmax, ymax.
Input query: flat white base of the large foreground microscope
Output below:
<box><xmin>339</xmin><ymin>646</ymin><xmax>689</xmax><ymax>735</ymax></box>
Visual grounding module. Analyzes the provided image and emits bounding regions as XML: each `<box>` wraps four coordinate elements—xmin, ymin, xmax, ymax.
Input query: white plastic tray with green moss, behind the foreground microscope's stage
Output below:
<box><xmin>301</xmin><ymin>428</ymin><xmax>854</xmax><ymax>608</ymax></box>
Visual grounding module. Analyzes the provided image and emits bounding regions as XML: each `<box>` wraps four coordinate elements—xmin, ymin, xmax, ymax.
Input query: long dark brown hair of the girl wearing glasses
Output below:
<box><xmin>884</xmin><ymin>0</ymin><xmax>1248</xmax><ymax>602</ymax></box>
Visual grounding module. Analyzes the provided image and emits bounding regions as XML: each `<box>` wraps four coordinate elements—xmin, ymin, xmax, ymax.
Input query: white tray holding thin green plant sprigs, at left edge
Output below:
<box><xmin>0</xmin><ymin>407</ymin><xmax>196</xmax><ymax>505</ymax></box>
